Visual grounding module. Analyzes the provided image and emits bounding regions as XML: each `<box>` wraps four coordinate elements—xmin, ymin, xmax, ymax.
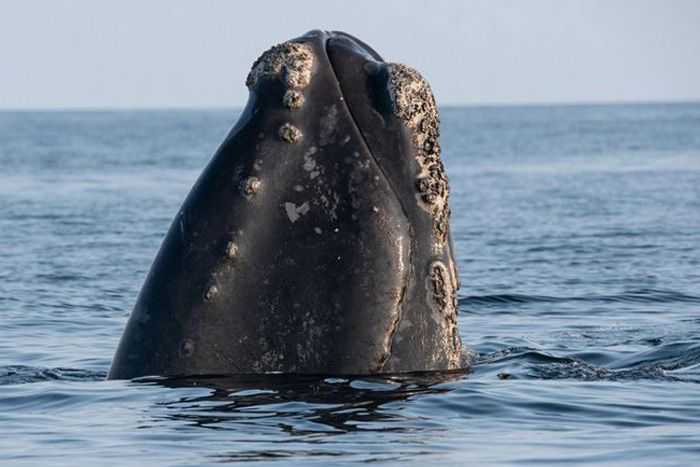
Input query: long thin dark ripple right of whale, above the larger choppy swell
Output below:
<box><xmin>459</xmin><ymin>289</ymin><xmax>700</xmax><ymax>306</ymax></box>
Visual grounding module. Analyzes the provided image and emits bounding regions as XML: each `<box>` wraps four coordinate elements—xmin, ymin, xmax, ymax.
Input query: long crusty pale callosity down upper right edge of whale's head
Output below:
<box><xmin>388</xmin><ymin>63</ymin><xmax>450</xmax><ymax>249</ymax></box>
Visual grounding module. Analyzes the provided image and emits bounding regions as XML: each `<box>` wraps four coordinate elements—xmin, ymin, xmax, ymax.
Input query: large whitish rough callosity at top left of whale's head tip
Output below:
<box><xmin>246</xmin><ymin>42</ymin><xmax>314</xmax><ymax>90</ymax></box>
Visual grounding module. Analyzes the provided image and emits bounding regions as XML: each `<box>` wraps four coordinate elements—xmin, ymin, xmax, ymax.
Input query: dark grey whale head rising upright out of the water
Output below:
<box><xmin>109</xmin><ymin>31</ymin><xmax>466</xmax><ymax>379</ymax></box>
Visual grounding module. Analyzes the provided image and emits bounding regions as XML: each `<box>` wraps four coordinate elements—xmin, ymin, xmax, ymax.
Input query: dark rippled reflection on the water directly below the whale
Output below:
<box><xmin>135</xmin><ymin>371</ymin><xmax>466</xmax><ymax>436</ymax></box>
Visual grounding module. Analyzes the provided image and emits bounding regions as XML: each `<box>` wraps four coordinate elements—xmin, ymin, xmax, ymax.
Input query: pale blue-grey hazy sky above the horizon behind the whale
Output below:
<box><xmin>0</xmin><ymin>0</ymin><xmax>700</xmax><ymax>110</ymax></box>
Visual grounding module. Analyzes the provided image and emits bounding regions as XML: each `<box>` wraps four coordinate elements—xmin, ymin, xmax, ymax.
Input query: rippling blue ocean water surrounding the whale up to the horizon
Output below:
<box><xmin>0</xmin><ymin>104</ymin><xmax>700</xmax><ymax>466</ymax></box>
